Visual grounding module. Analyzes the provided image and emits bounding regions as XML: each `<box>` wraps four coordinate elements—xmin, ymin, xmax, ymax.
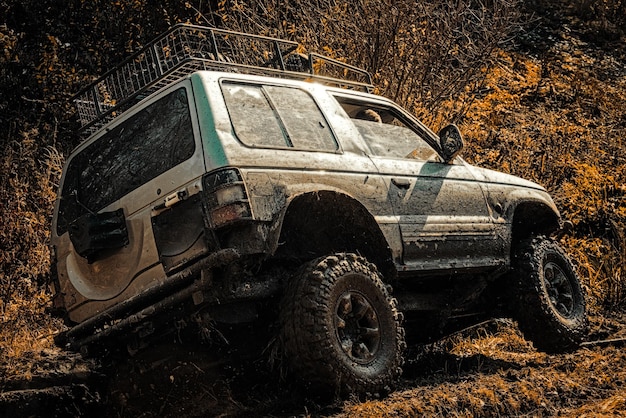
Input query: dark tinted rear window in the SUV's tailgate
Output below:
<box><xmin>57</xmin><ymin>88</ymin><xmax>195</xmax><ymax>235</ymax></box>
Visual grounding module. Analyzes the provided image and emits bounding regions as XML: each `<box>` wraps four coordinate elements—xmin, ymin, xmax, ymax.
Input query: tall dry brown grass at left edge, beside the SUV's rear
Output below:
<box><xmin>0</xmin><ymin>129</ymin><xmax>62</xmax><ymax>384</ymax></box>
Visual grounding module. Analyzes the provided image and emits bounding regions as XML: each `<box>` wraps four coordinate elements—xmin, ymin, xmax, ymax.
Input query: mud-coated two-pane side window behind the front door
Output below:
<box><xmin>222</xmin><ymin>82</ymin><xmax>338</xmax><ymax>151</ymax></box>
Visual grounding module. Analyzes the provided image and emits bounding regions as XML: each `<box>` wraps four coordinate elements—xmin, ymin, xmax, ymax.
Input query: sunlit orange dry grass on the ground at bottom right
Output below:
<box><xmin>334</xmin><ymin>323</ymin><xmax>626</xmax><ymax>417</ymax></box>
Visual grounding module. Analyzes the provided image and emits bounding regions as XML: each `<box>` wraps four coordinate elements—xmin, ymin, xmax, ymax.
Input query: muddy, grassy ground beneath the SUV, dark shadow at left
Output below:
<box><xmin>0</xmin><ymin>314</ymin><xmax>626</xmax><ymax>417</ymax></box>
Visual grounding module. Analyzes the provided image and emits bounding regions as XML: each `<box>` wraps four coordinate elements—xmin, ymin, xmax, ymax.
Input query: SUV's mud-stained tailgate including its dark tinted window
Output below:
<box><xmin>53</xmin><ymin>82</ymin><xmax>204</xmax><ymax>321</ymax></box>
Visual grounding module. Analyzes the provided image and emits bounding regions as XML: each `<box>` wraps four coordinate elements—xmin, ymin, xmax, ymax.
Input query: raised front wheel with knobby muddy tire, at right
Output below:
<box><xmin>514</xmin><ymin>237</ymin><xmax>588</xmax><ymax>353</ymax></box>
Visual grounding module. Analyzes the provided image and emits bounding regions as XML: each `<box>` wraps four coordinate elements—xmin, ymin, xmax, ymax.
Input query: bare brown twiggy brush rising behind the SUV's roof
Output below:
<box><xmin>211</xmin><ymin>0</ymin><xmax>525</xmax><ymax>131</ymax></box>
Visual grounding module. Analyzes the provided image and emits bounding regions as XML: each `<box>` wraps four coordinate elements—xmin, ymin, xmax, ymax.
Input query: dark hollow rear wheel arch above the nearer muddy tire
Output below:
<box><xmin>273</xmin><ymin>190</ymin><xmax>396</xmax><ymax>280</ymax></box>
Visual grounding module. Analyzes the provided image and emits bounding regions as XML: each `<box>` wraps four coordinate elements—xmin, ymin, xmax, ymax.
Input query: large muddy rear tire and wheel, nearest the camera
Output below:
<box><xmin>280</xmin><ymin>253</ymin><xmax>406</xmax><ymax>395</ymax></box>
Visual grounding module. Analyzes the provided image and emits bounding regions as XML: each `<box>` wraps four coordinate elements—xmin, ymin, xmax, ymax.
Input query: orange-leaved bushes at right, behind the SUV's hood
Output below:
<box><xmin>454</xmin><ymin>34</ymin><xmax>626</xmax><ymax>308</ymax></box>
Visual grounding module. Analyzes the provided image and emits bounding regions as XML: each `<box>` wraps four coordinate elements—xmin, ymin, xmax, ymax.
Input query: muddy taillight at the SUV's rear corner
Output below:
<box><xmin>202</xmin><ymin>168</ymin><xmax>252</xmax><ymax>228</ymax></box>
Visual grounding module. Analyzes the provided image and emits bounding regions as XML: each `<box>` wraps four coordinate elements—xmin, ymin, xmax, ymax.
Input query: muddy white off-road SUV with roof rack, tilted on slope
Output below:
<box><xmin>51</xmin><ymin>25</ymin><xmax>586</xmax><ymax>392</ymax></box>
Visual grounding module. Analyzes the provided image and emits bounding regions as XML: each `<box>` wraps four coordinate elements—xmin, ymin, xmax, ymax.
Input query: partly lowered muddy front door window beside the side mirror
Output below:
<box><xmin>336</xmin><ymin>97</ymin><xmax>438</xmax><ymax>161</ymax></box>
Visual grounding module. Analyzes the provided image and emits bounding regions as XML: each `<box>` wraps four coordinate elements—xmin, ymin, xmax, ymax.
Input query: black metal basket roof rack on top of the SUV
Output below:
<box><xmin>74</xmin><ymin>24</ymin><xmax>373</xmax><ymax>136</ymax></box>
